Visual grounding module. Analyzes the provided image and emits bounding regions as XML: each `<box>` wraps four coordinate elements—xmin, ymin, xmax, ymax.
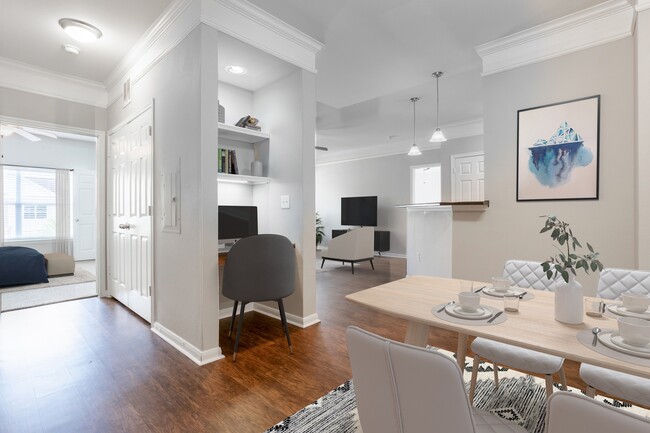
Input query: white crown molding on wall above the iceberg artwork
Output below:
<box><xmin>475</xmin><ymin>0</ymin><xmax>632</xmax><ymax>76</ymax></box>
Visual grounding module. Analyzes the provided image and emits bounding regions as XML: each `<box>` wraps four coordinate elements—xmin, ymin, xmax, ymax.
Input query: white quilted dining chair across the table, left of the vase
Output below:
<box><xmin>469</xmin><ymin>260</ymin><xmax>566</xmax><ymax>401</ymax></box>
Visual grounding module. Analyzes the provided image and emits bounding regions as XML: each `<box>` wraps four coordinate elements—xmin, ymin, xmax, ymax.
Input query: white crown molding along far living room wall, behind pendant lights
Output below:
<box><xmin>316</xmin><ymin>118</ymin><xmax>483</xmax><ymax>166</ymax></box>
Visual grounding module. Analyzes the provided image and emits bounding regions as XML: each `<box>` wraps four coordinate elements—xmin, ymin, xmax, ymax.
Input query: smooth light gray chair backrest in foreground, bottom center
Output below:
<box><xmin>347</xmin><ymin>327</ymin><xmax>475</xmax><ymax>433</ymax></box>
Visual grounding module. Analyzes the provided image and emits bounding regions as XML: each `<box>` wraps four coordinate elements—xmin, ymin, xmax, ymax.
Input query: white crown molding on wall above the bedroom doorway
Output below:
<box><xmin>0</xmin><ymin>57</ymin><xmax>108</xmax><ymax>108</ymax></box>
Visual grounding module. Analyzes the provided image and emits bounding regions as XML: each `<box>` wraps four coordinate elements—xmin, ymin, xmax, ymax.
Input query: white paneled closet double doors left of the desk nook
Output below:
<box><xmin>108</xmin><ymin>108</ymin><xmax>153</xmax><ymax>322</ymax></box>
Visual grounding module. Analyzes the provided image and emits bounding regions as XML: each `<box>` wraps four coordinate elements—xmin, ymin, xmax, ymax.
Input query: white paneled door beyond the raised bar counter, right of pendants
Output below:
<box><xmin>451</xmin><ymin>152</ymin><xmax>485</xmax><ymax>201</ymax></box>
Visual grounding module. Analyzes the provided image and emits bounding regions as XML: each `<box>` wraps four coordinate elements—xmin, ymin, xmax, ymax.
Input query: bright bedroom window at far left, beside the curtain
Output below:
<box><xmin>3</xmin><ymin>166</ymin><xmax>56</xmax><ymax>240</ymax></box>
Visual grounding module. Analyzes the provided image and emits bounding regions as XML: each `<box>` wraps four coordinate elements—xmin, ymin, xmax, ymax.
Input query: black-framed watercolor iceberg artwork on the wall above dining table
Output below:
<box><xmin>517</xmin><ymin>95</ymin><xmax>600</xmax><ymax>201</ymax></box>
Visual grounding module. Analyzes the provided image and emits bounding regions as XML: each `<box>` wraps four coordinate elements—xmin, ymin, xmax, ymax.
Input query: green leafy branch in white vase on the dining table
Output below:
<box><xmin>540</xmin><ymin>215</ymin><xmax>603</xmax><ymax>324</ymax></box>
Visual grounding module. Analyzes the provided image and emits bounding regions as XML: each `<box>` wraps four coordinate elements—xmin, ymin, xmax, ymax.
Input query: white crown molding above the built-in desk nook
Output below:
<box><xmin>201</xmin><ymin>0</ymin><xmax>323</xmax><ymax>73</ymax></box>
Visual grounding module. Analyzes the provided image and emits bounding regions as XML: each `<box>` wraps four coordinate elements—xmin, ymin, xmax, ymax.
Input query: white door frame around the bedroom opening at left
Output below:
<box><xmin>0</xmin><ymin>115</ymin><xmax>108</xmax><ymax>297</ymax></box>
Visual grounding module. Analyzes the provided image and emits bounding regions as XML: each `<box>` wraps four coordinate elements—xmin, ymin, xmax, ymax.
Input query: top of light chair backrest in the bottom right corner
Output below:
<box><xmin>546</xmin><ymin>391</ymin><xmax>650</xmax><ymax>433</ymax></box>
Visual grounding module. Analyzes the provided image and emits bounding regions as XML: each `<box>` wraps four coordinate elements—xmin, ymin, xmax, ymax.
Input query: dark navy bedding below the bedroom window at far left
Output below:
<box><xmin>0</xmin><ymin>247</ymin><xmax>48</xmax><ymax>287</ymax></box>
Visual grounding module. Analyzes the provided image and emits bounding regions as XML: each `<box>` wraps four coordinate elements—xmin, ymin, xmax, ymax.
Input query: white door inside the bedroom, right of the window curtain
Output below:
<box><xmin>72</xmin><ymin>170</ymin><xmax>97</xmax><ymax>260</ymax></box>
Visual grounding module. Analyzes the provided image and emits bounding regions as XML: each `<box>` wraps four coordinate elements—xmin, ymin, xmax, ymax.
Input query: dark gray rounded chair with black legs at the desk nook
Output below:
<box><xmin>222</xmin><ymin>234</ymin><xmax>296</xmax><ymax>361</ymax></box>
